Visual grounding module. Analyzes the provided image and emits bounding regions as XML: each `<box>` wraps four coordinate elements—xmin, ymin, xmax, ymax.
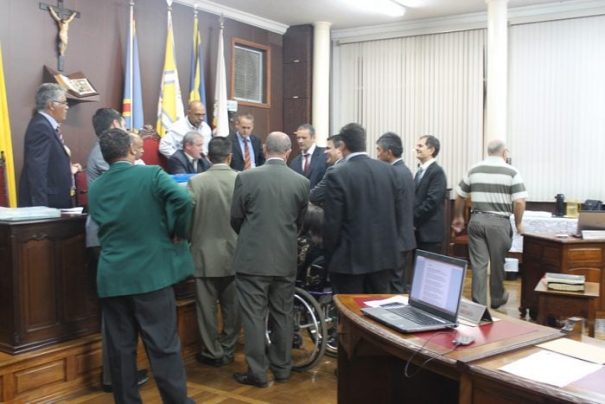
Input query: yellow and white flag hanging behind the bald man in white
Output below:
<box><xmin>156</xmin><ymin>0</ymin><xmax>184</xmax><ymax>136</ymax></box>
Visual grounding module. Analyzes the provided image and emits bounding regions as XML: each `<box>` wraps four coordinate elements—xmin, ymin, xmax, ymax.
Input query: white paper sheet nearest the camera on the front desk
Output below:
<box><xmin>500</xmin><ymin>351</ymin><xmax>602</xmax><ymax>387</ymax></box>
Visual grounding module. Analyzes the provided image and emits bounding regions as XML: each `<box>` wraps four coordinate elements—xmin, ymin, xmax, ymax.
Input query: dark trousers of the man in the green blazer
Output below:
<box><xmin>101</xmin><ymin>287</ymin><xmax>192</xmax><ymax>404</ymax></box>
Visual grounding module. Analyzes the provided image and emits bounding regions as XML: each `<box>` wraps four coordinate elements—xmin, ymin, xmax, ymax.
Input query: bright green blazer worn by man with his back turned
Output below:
<box><xmin>88</xmin><ymin>161</ymin><xmax>193</xmax><ymax>297</ymax></box>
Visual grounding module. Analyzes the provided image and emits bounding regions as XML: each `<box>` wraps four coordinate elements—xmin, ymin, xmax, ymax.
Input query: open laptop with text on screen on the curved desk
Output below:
<box><xmin>361</xmin><ymin>250</ymin><xmax>467</xmax><ymax>333</ymax></box>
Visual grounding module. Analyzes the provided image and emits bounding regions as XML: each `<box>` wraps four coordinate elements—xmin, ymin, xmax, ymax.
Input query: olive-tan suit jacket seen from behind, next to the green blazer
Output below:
<box><xmin>188</xmin><ymin>164</ymin><xmax>237</xmax><ymax>277</ymax></box>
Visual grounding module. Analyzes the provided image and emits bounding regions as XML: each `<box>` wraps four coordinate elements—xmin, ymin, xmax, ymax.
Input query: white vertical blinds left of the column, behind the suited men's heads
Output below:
<box><xmin>332</xmin><ymin>30</ymin><xmax>485</xmax><ymax>191</ymax></box>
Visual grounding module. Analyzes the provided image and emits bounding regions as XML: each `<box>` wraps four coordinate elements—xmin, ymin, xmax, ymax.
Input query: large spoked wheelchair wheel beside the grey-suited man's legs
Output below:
<box><xmin>292</xmin><ymin>288</ymin><xmax>327</xmax><ymax>372</ymax></box>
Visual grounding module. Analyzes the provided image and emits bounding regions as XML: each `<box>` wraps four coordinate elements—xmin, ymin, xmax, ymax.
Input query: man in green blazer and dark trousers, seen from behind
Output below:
<box><xmin>89</xmin><ymin>129</ymin><xmax>193</xmax><ymax>403</ymax></box>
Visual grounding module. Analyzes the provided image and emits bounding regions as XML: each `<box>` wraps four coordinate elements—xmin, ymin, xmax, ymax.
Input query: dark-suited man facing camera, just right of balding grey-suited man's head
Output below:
<box><xmin>290</xmin><ymin>123</ymin><xmax>327</xmax><ymax>189</ymax></box>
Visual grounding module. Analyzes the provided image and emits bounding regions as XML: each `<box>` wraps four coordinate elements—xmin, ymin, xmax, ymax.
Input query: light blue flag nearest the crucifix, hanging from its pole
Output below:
<box><xmin>122</xmin><ymin>4</ymin><xmax>145</xmax><ymax>129</ymax></box>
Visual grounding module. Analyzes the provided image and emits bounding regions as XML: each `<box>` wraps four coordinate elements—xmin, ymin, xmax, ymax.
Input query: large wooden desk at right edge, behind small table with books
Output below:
<box><xmin>519</xmin><ymin>234</ymin><xmax>605</xmax><ymax>319</ymax></box>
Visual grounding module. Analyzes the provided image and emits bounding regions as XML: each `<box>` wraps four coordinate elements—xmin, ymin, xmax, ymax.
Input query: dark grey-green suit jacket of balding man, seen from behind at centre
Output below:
<box><xmin>231</xmin><ymin>159</ymin><xmax>309</xmax><ymax>277</ymax></box>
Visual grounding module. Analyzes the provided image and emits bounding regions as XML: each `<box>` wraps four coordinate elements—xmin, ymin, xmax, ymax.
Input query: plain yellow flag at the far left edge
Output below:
<box><xmin>0</xmin><ymin>41</ymin><xmax>17</xmax><ymax>208</ymax></box>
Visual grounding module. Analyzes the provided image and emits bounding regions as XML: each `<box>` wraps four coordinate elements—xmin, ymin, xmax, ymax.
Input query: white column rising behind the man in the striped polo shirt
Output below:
<box><xmin>484</xmin><ymin>0</ymin><xmax>508</xmax><ymax>145</ymax></box>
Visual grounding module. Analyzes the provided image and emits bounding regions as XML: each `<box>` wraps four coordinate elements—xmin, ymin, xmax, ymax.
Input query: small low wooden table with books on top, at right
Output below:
<box><xmin>535</xmin><ymin>279</ymin><xmax>599</xmax><ymax>337</ymax></box>
